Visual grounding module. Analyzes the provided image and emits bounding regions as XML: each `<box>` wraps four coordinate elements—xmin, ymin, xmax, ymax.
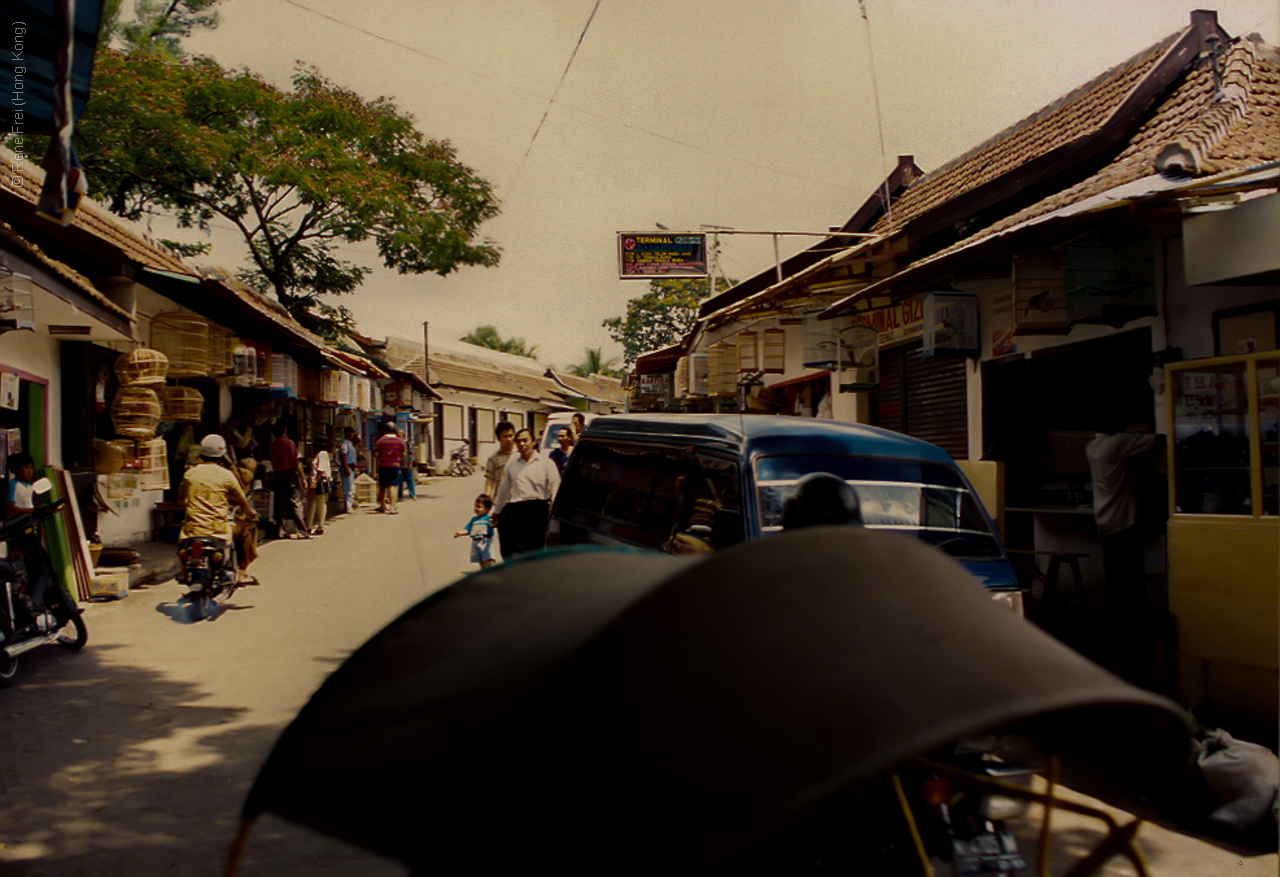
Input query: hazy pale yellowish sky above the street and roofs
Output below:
<box><xmin>156</xmin><ymin>0</ymin><xmax>1280</xmax><ymax>366</ymax></box>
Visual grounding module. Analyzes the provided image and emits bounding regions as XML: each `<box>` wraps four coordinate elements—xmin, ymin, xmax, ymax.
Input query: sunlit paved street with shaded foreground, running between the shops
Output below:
<box><xmin>0</xmin><ymin>476</ymin><xmax>1277</xmax><ymax>877</ymax></box>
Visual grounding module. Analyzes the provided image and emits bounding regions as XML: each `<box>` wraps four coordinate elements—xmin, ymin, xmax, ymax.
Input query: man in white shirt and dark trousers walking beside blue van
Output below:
<box><xmin>489</xmin><ymin>429</ymin><xmax>559</xmax><ymax>559</ymax></box>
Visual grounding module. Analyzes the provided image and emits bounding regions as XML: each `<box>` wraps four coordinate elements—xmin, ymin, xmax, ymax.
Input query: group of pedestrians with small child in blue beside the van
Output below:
<box><xmin>453</xmin><ymin>414</ymin><xmax>586</xmax><ymax>567</ymax></box>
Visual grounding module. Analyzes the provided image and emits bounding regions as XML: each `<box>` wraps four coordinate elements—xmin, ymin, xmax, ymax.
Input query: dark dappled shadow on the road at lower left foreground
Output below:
<box><xmin>0</xmin><ymin>647</ymin><xmax>403</xmax><ymax>877</ymax></box>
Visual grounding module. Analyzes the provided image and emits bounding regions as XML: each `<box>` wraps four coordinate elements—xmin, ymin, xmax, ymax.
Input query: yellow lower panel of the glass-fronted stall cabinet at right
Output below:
<box><xmin>1169</xmin><ymin>515</ymin><xmax>1280</xmax><ymax>718</ymax></box>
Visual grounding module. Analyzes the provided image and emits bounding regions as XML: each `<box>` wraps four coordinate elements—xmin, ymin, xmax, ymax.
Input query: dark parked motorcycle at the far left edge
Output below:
<box><xmin>0</xmin><ymin>478</ymin><xmax>88</xmax><ymax>688</ymax></box>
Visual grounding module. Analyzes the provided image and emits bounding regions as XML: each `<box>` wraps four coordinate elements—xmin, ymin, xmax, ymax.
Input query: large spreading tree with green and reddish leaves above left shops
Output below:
<box><xmin>68</xmin><ymin>50</ymin><xmax>500</xmax><ymax>338</ymax></box>
